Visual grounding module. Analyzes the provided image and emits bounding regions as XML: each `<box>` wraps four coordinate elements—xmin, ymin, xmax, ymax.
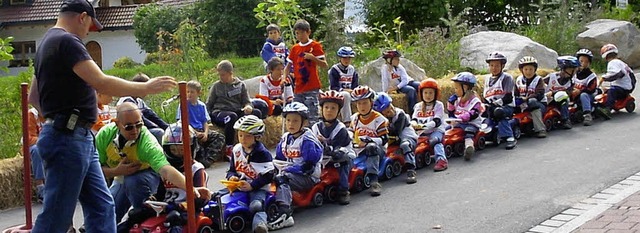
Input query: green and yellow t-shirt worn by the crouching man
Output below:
<box><xmin>95</xmin><ymin>123</ymin><xmax>169</xmax><ymax>172</ymax></box>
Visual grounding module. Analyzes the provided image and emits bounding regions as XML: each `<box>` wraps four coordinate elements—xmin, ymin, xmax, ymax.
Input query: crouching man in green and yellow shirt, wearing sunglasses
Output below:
<box><xmin>95</xmin><ymin>102</ymin><xmax>211</xmax><ymax>222</ymax></box>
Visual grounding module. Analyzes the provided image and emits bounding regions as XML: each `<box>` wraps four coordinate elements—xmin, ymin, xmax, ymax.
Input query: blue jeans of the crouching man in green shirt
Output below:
<box><xmin>109</xmin><ymin>169</ymin><xmax>160</xmax><ymax>222</ymax></box>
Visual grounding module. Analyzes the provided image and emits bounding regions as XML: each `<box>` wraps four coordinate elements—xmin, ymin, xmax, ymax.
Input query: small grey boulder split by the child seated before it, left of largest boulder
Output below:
<box><xmin>358</xmin><ymin>58</ymin><xmax>427</xmax><ymax>91</ymax></box>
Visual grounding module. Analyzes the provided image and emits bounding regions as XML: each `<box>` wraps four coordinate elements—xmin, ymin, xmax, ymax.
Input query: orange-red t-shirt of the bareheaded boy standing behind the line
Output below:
<box><xmin>287</xmin><ymin>40</ymin><xmax>324</xmax><ymax>94</ymax></box>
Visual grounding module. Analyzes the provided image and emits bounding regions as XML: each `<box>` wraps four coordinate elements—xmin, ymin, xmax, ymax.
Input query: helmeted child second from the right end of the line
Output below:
<box><xmin>571</xmin><ymin>49</ymin><xmax>598</xmax><ymax>126</ymax></box>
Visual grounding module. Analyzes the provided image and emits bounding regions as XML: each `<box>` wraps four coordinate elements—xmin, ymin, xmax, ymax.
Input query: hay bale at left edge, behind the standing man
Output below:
<box><xmin>0</xmin><ymin>155</ymin><xmax>24</xmax><ymax>210</ymax></box>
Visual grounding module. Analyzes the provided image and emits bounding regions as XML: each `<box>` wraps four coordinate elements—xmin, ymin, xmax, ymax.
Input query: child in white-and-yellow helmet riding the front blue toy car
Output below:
<box><xmin>227</xmin><ymin>115</ymin><xmax>275</xmax><ymax>232</ymax></box>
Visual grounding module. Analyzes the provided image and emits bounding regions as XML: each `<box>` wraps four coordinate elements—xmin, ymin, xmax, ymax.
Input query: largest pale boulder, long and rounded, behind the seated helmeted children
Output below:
<box><xmin>459</xmin><ymin>31</ymin><xmax>558</xmax><ymax>70</ymax></box>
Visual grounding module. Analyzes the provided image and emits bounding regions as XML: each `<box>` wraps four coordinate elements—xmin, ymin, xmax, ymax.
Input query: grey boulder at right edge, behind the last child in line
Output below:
<box><xmin>576</xmin><ymin>19</ymin><xmax>640</xmax><ymax>68</ymax></box>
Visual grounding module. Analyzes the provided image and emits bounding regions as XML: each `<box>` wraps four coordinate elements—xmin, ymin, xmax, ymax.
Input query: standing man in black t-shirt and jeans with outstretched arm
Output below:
<box><xmin>29</xmin><ymin>0</ymin><xmax>176</xmax><ymax>233</ymax></box>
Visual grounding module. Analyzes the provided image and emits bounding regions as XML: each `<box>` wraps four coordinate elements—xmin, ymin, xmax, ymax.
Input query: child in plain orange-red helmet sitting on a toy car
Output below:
<box><xmin>411</xmin><ymin>78</ymin><xmax>449</xmax><ymax>172</ymax></box>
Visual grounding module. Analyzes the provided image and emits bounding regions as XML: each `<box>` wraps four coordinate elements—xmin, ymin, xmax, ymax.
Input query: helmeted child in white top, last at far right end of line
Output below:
<box><xmin>600</xmin><ymin>44</ymin><xmax>636</xmax><ymax>119</ymax></box>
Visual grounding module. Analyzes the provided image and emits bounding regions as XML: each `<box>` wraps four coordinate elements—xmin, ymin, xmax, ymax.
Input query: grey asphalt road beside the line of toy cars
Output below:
<box><xmin>0</xmin><ymin>77</ymin><xmax>640</xmax><ymax>232</ymax></box>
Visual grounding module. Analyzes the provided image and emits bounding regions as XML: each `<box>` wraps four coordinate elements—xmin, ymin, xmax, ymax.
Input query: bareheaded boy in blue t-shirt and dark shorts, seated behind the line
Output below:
<box><xmin>176</xmin><ymin>80</ymin><xmax>224</xmax><ymax>168</ymax></box>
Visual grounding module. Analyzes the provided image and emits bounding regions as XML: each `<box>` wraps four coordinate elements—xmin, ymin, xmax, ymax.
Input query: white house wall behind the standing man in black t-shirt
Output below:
<box><xmin>0</xmin><ymin>23</ymin><xmax>147</xmax><ymax>76</ymax></box>
